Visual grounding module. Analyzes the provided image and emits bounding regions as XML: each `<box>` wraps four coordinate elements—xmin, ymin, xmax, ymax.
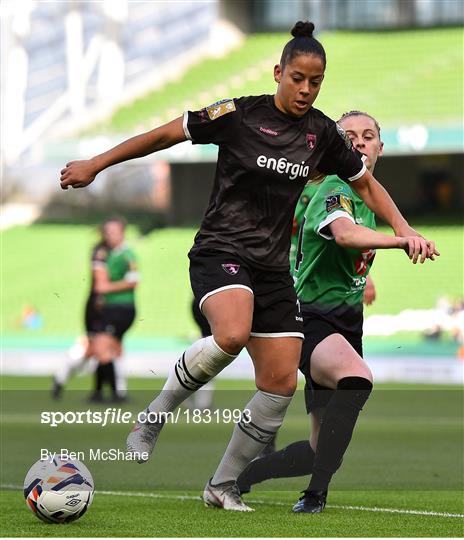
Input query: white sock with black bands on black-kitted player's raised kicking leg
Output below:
<box><xmin>148</xmin><ymin>336</ymin><xmax>237</xmax><ymax>413</ymax></box>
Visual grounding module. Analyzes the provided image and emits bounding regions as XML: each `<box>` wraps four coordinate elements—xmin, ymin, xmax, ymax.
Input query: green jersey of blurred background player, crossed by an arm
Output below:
<box><xmin>95</xmin><ymin>244</ymin><xmax>136</xmax><ymax>305</ymax></box>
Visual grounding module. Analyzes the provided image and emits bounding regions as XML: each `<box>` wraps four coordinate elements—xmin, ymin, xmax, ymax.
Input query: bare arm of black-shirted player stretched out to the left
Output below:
<box><xmin>60</xmin><ymin>117</ymin><xmax>187</xmax><ymax>189</ymax></box>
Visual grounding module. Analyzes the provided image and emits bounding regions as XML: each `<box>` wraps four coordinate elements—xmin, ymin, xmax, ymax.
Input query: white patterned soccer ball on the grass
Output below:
<box><xmin>24</xmin><ymin>456</ymin><xmax>94</xmax><ymax>523</ymax></box>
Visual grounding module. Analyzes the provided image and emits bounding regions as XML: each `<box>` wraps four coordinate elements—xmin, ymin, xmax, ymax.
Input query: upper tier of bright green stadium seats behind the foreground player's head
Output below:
<box><xmin>96</xmin><ymin>28</ymin><xmax>462</xmax><ymax>132</ymax></box>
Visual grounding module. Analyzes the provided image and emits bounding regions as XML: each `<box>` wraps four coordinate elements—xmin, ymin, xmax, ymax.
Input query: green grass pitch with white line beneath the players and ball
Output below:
<box><xmin>0</xmin><ymin>377</ymin><xmax>464</xmax><ymax>537</ymax></box>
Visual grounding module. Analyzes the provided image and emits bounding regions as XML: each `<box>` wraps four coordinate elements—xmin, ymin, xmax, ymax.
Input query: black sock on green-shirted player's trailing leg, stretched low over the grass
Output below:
<box><xmin>238</xmin><ymin>441</ymin><xmax>314</xmax><ymax>490</ymax></box>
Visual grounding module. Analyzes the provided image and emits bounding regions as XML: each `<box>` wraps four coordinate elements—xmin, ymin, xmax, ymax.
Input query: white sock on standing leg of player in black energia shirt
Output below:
<box><xmin>211</xmin><ymin>390</ymin><xmax>292</xmax><ymax>485</ymax></box>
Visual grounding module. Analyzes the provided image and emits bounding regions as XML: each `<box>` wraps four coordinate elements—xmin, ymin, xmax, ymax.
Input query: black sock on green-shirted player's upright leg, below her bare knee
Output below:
<box><xmin>308</xmin><ymin>377</ymin><xmax>372</xmax><ymax>491</ymax></box>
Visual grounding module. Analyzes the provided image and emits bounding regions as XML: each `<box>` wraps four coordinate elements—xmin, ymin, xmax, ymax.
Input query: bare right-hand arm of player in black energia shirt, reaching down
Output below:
<box><xmin>351</xmin><ymin>171</ymin><xmax>440</xmax><ymax>260</ymax></box>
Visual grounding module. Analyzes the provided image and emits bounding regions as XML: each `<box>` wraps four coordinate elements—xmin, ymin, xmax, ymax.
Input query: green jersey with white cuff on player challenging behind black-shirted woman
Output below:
<box><xmin>294</xmin><ymin>176</ymin><xmax>376</xmax><ymax>326</ymax></box>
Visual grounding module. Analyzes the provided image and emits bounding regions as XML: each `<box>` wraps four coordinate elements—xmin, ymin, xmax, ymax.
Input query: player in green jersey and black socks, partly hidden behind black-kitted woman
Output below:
<box><xmin>238</xmin><ymin>111</ymin><xmax>428</xmax><ymax>513</ymax></box>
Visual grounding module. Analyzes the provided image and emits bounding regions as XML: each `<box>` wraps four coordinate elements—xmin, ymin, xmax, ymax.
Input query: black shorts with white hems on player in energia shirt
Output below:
<box><xmin>190</xmin><ymin>250</ymin><xmax>303</xmax><ymax>338</ymax></box>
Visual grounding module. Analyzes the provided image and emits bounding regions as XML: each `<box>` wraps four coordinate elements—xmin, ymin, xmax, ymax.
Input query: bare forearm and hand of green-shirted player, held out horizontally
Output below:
<box><xmin>328</xmin><ymin>217</ymin><xmax>427</xmax><ymax>264</ymax></box>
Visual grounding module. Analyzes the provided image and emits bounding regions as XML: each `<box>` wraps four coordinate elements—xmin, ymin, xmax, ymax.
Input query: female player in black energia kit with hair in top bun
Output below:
<box><xmin>61</xmin><ymin>22</ymin><xmax>435</xmax><ymax>511</ymax></box>
